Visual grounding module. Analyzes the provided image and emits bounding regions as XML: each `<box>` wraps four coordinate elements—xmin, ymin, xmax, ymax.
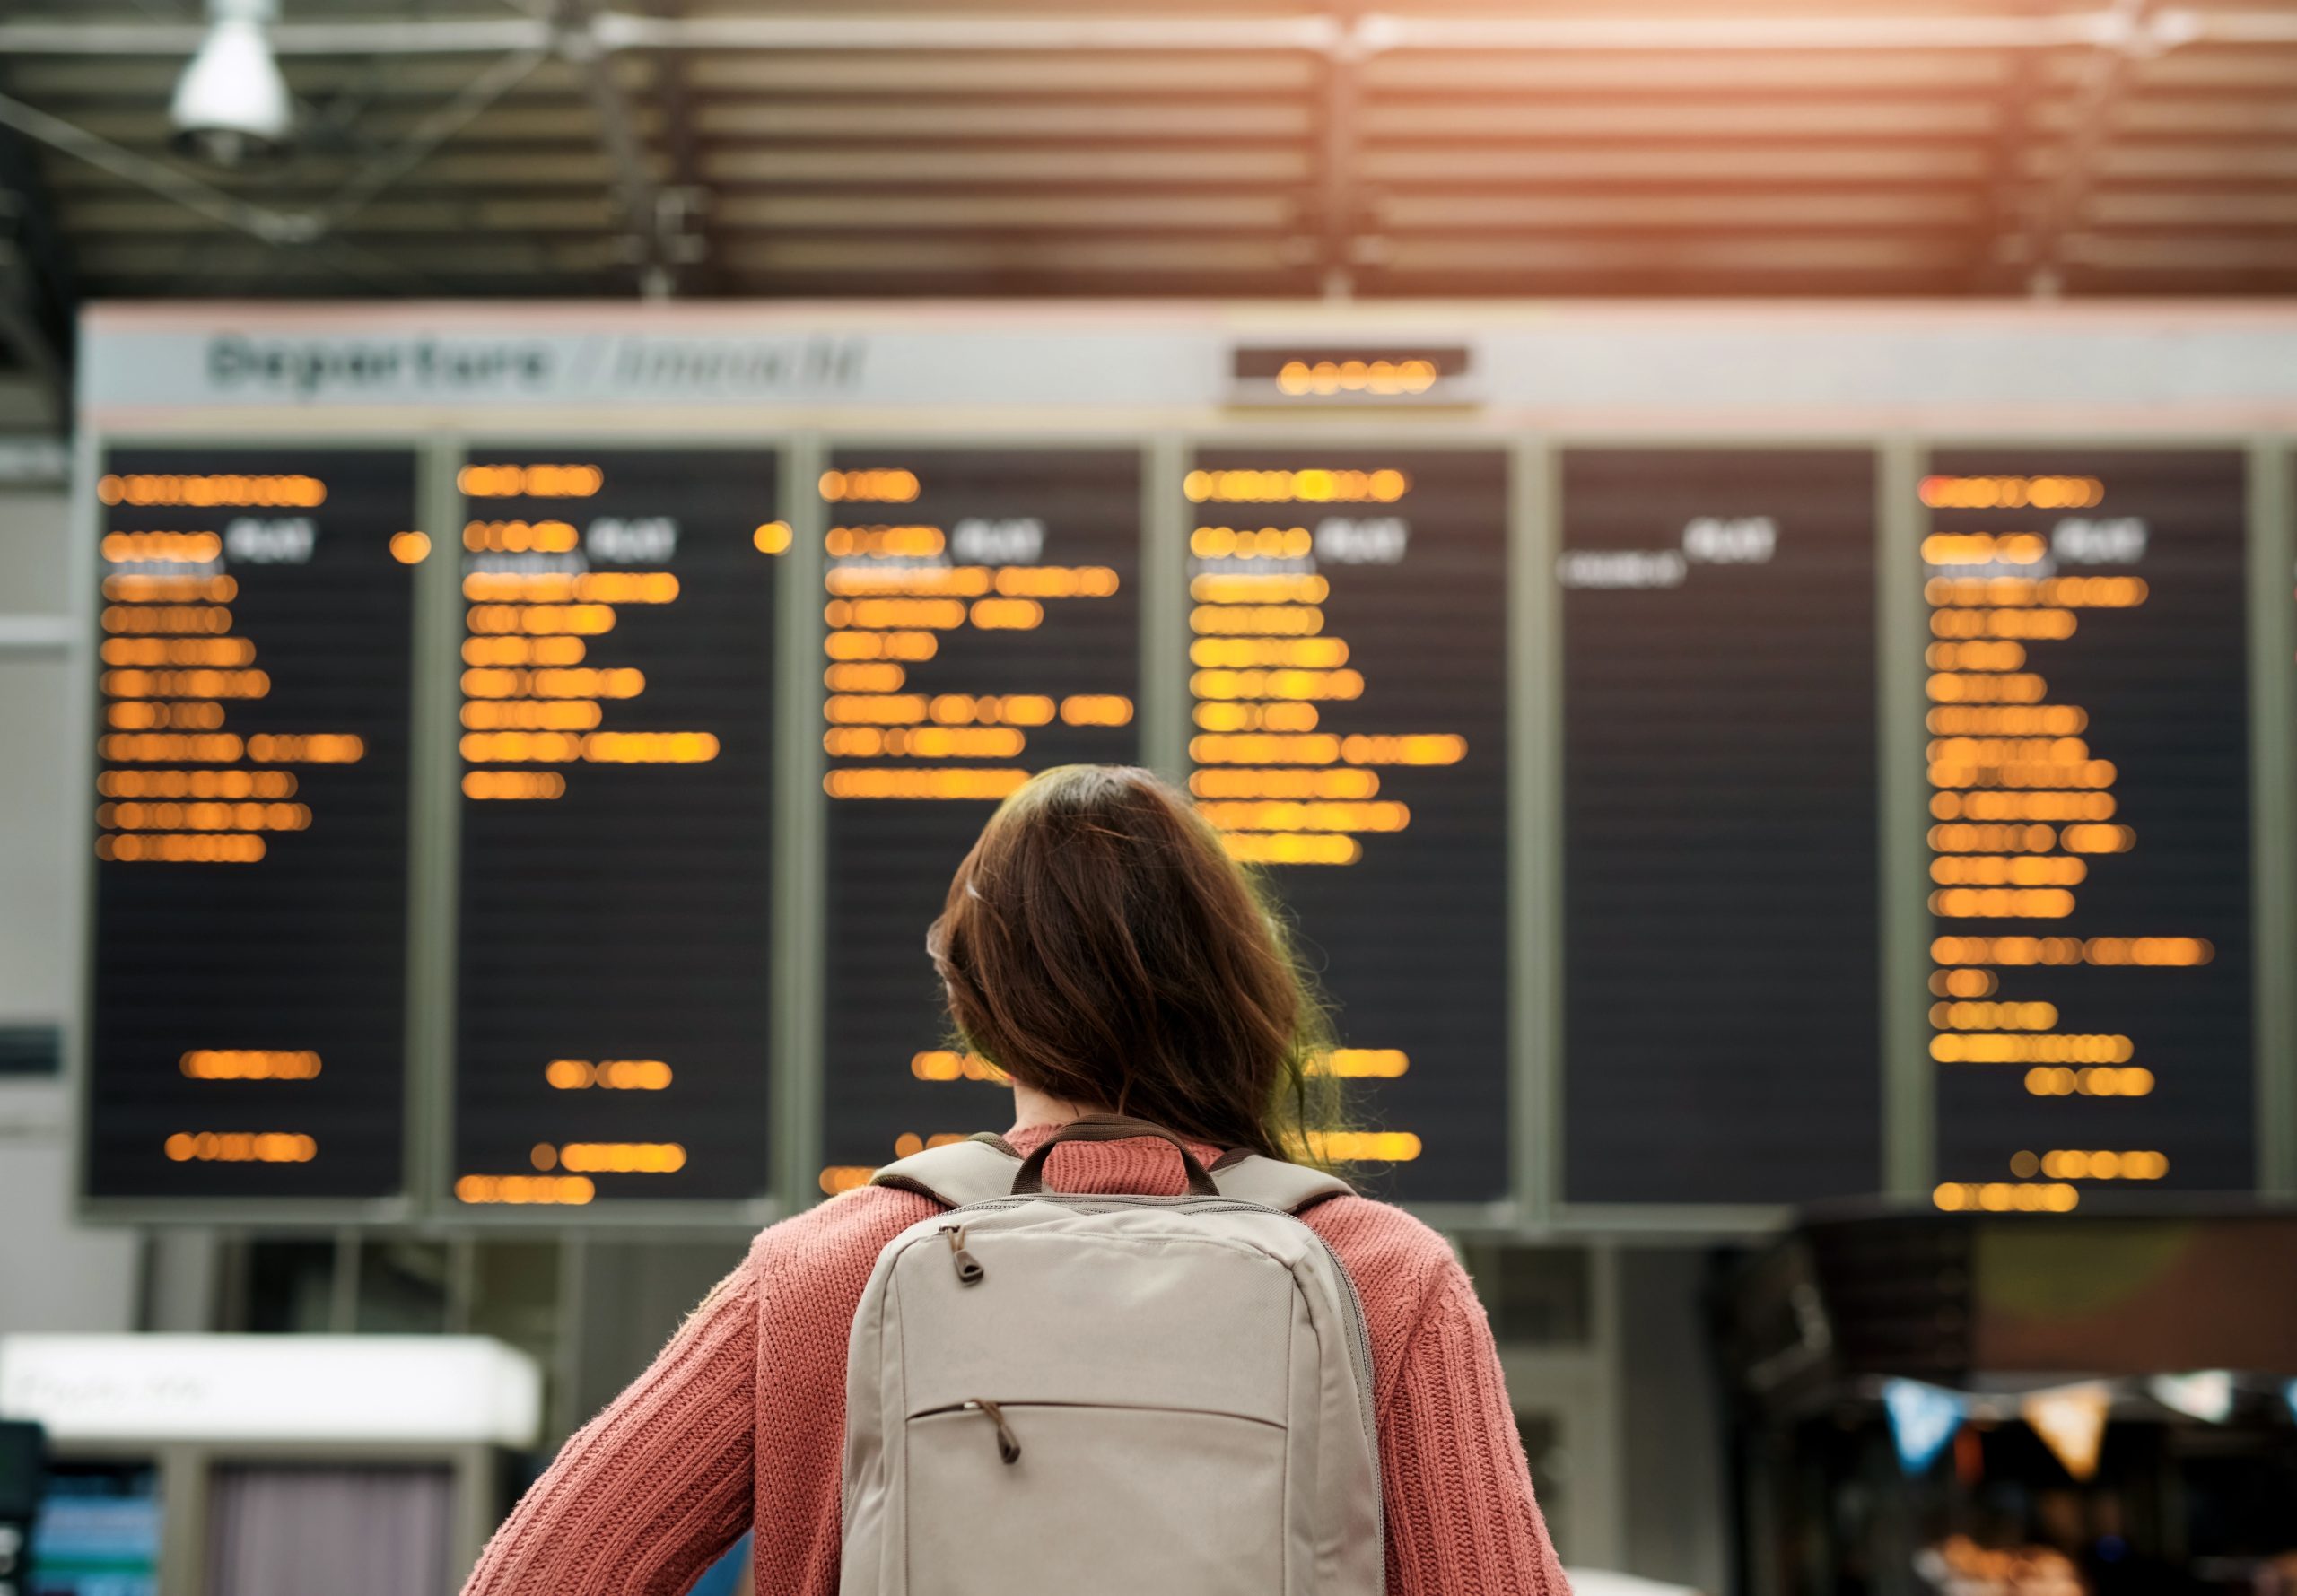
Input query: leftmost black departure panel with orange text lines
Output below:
<box><xmin>83</xmin><ymin>448</ymin><xmax>430</xmax><ymax>1199</ymax></box>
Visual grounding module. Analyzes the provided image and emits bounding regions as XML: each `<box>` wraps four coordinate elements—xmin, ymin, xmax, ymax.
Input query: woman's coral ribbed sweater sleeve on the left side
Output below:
<box><xmin>464</xmin><ymin>1263</ymin><xmax>758</xmax><ymax>1596</ymax></box>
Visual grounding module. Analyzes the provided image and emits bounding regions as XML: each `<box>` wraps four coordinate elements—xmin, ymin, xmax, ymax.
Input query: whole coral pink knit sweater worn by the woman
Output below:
<box><xmin>464</xmin><ymin>1128</ymin><xmax>1568</xmax><ymax>1596</ymax></box>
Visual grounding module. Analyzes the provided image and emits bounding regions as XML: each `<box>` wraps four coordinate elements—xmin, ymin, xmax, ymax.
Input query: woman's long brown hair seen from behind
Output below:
<box><xmin>926</xmin><ymin>764</ymin><xmax>1332</xmax><ymax>1160</ymax></box>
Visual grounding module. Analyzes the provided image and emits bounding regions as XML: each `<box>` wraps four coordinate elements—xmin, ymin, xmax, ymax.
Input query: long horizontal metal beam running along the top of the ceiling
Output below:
<box><xmin>0</xmin><ymin>4</ymin><xmax>2297</xmax><ymax>55</ymax></box>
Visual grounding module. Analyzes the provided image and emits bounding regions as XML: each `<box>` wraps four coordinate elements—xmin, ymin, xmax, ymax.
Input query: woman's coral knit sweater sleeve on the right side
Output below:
<box><xmin>1381</xmin><ymin>1259</ymin><xmax>1571</xmax><ymax>1596</ymax></box>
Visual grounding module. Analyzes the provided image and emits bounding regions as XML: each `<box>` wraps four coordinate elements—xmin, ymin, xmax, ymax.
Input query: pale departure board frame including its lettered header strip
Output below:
<box><xmin>65</xmin><ymin>305</ymin><xmax>2297</xmax><ymax>1238</ymax></box>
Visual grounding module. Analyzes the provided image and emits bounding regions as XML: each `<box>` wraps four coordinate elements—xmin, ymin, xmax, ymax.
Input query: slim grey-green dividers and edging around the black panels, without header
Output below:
<box><xmin>74</xmin><ymin>420</ymin><xmax>2297</xmax><ymax>1235</ymax></box>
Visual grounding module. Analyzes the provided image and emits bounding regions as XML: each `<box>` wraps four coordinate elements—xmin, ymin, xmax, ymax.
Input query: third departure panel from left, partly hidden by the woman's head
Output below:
<box><xmin>820</xmin><ymin>448</ymin><xmax>1141</xmax><ymax>1191</ymax></box>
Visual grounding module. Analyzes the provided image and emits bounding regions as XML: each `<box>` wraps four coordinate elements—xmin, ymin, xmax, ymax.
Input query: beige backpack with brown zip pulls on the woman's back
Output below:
<box><xmin>838</xmin><ymin>1116</ymin><xmax>1385</xmax><ymax>1596</ymax></box>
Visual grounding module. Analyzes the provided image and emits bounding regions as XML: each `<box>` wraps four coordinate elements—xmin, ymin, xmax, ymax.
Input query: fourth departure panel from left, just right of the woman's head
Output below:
<box><xmin>1183</xmin><ymin>448</ymin><xmax>1509</xmax><ymax>1201</ymax></box>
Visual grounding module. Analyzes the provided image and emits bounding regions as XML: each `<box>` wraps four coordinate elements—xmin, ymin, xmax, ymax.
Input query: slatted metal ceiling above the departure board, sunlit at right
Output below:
<box><xmin>0</xmin><ymin>0</ymin><xmax>2297</xmax><ymax>399</ymax></box>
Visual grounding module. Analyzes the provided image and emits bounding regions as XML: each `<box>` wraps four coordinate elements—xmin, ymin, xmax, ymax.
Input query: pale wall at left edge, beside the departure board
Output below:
<box><xmin>0</xmin><ymin>445</ymin><xmax>140</xmax><ymax>1334</ymax></box>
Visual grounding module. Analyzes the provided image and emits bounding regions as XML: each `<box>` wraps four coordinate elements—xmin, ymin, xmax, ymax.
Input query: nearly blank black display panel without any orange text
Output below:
<box><xmin>1555</xmin><ymin>450</ymin><xmax>1882</xmax><ymax>1203</ymax></box>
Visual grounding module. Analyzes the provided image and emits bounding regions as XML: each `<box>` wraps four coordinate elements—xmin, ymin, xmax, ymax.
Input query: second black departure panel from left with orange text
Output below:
<box><xmin>455</xmin><ymin>443</ymin><xmax>790</xmax><ymax>1206</ymax></box>
